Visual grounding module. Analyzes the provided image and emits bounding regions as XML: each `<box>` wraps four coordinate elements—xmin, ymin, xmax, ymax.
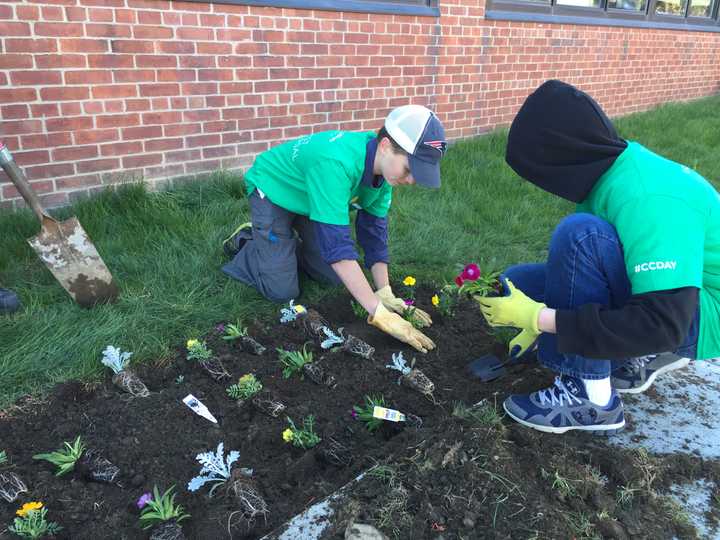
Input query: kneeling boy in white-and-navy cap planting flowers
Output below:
<box><xmin>223</xmin><ymin>105</ymin><xmax>446</xmax><ymax>352</ymax></box>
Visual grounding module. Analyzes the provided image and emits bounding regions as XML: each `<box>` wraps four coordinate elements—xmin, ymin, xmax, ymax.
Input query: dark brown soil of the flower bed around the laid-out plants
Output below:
<box><xmin>0</xmin><ymin>290</ymin><xmax>720</xmax><ymax>540</ymax></box>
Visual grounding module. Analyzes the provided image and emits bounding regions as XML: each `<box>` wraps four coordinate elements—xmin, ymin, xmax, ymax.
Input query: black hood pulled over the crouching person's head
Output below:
<box><xmin>505</xmin><ymin>77</ymin><xmax>627</xmax><ymax>203</ymax></box>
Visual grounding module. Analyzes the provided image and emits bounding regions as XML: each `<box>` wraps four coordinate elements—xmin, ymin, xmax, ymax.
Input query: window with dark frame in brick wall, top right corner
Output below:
<box><xmin>485</xmin><ymin>0</ymin><xmax>720</xmax><ymax>32</ymax></box>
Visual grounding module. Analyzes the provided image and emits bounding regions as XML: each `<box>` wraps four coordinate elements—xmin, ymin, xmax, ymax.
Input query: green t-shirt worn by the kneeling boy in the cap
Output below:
<box><xmin>245</xmin><ymin>131</ymin><xmax>392</xmax><ymax>225</ymax></box>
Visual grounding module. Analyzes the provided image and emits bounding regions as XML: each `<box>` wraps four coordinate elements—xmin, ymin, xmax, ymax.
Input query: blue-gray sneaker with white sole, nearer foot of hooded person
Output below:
<box><xmin>503</xmin><ymin>375</ymin><xmax>625</xmax><ymax>435</ymax></box>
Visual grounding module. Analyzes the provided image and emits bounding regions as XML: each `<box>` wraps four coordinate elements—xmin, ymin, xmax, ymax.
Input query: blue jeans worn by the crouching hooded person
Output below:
<box><xmin>505</xmin><ymin>214</ymin><xmax>699</xmax><ymax>379</ymax></box>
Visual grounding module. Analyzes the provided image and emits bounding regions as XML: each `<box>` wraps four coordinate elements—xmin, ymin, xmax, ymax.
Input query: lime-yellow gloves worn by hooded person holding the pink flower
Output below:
<box><xmin>476</xmin><ymin>279</ymin><xmax>547</xmax><ymax>357</ymax></box>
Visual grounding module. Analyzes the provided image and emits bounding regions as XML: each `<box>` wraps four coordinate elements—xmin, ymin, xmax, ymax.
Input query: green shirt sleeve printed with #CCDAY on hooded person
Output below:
<box><xmin>611</xmin><ymin>195</ymin><xmax>705</xmax><ymax>294</ymax></box>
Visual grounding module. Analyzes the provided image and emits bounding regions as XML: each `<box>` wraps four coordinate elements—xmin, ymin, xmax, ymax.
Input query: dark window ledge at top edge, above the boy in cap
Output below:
<box><xmin>184</xmin><ymin>0</ymin><xmax>440</xmax><ymax>17</ymax></box>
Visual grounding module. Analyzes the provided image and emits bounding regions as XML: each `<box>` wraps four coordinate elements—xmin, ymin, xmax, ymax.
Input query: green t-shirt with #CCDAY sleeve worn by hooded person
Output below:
<box><xmin>577</xmin><ymin>142</ymin><xmax>720</xmax><ymax>358</ymax></box>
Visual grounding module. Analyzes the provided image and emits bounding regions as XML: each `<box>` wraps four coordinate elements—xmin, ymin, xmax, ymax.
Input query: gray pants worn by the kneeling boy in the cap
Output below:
<box><xmin>222</xmin><ymin>190</ymin><xmax>341</xmax><ymax>302</ymax></box>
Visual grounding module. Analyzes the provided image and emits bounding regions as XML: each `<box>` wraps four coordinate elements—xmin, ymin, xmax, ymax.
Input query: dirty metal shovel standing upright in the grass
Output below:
<box><xmin>0</xmin><ymin>142</ymin><xmax>119</xmax><ymax>308</ymax></box>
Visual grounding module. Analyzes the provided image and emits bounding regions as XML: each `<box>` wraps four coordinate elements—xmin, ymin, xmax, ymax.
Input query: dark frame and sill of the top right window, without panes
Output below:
<box><xmin>485</xmin><ymin>0</ymin><xmax>720</xmax><ymax>32</ymax></box>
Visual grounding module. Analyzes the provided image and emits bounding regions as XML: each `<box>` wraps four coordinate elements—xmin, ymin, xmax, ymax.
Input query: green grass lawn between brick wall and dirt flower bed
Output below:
<box><xmin>0</xmin><ymin>97</ymin><xmax>720</xmax><ymax>408</ymax></box>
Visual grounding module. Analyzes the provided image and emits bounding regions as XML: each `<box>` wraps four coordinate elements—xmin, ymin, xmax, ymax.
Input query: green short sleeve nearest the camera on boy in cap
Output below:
<box><xmin>305</xmin><ymin>160</ymin><xmax>352</xmax><ymax>225</ymax></box>
